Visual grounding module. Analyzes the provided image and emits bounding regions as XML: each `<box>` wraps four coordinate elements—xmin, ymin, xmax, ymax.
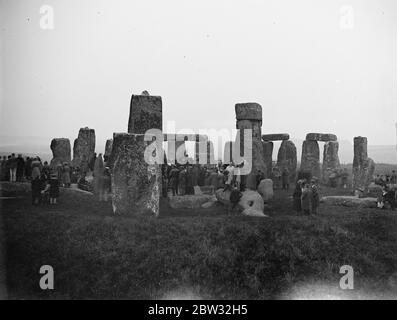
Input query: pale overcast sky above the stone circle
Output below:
<box><xmin>0</xmin><ymin>0</ymin><xmax>397</xmax><ymax>155</ymax></box>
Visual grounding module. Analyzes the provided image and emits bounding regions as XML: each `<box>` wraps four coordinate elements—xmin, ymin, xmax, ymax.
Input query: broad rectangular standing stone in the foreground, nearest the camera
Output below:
<box><xmin>111</xmin><ymin>133</ymin><xmax>161</xmax><ymax>216</ymax></box>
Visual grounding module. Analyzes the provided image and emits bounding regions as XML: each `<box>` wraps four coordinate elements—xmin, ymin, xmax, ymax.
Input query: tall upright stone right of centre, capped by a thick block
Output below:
<box><xmin>235</xmin><ymin>103</ymin><xmax>267</xmax><ymax>190</ymax></box>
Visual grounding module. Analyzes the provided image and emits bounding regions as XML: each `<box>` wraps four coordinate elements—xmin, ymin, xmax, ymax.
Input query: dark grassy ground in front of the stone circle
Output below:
<box><xmin>0</xmin><ymin>184</ymin><xmax>397</xmax><ymax>299</ymax></box>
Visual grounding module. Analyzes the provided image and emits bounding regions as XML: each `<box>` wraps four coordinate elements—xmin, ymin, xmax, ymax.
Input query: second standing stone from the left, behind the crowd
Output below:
<box><xmin>72</xmin><ymin>127</ymin><xmax>95</xmax><ymax>171</ymax></box>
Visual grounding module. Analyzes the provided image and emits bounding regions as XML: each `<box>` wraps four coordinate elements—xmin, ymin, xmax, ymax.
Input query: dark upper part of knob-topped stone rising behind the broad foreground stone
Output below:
<box><xmin>128</xmin><ymin>94</ymin><xmax>163</xmax><ymax>134</ymax></box>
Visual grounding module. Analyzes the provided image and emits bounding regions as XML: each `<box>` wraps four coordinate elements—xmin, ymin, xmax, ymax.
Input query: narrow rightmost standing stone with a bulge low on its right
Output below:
<box><xmin>353</xmin><ymin>137</ymin><xmax>375</xmax><ymax>189</ymax></box>
